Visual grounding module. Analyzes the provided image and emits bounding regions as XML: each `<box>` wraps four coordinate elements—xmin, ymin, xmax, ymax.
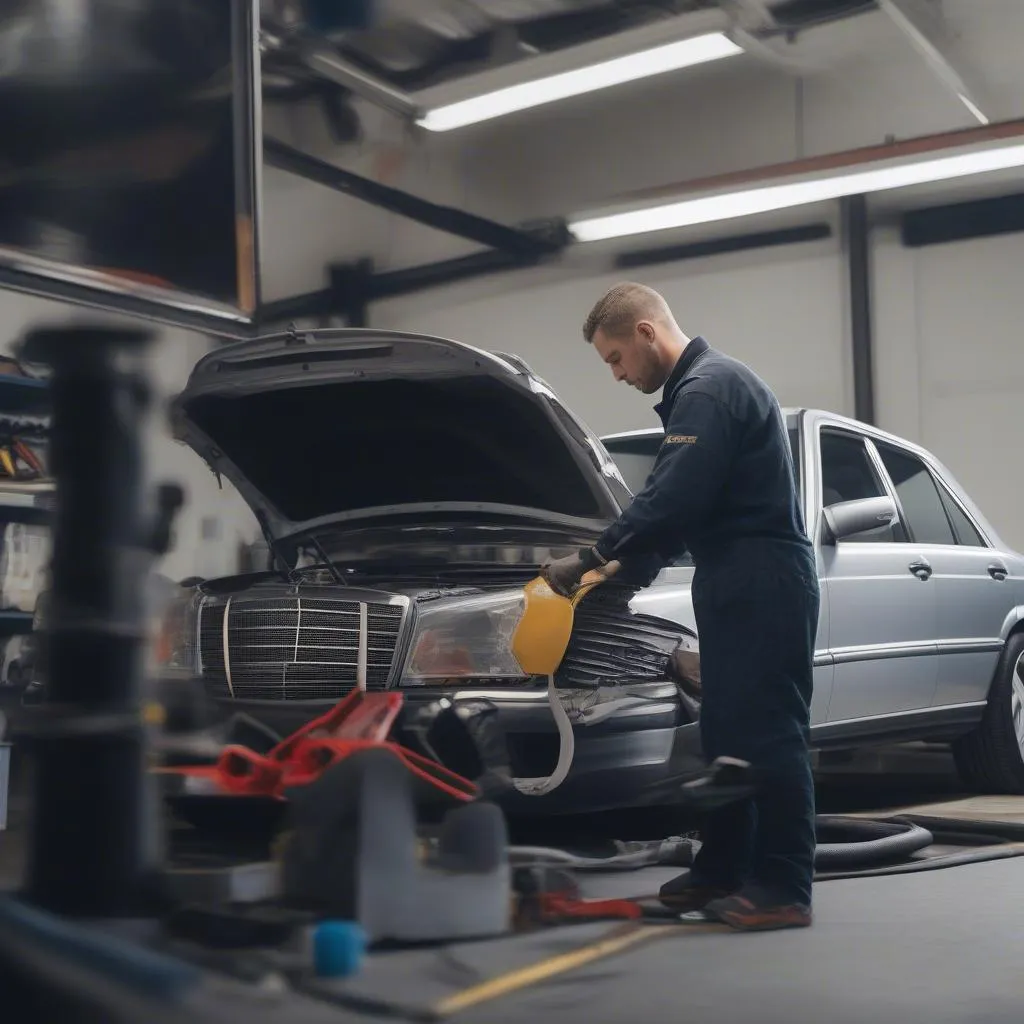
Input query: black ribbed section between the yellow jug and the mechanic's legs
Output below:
<box><xmin>555</xmin><ymin>595</ymin><xmax>684</xmax><ymax>688</ymax></box>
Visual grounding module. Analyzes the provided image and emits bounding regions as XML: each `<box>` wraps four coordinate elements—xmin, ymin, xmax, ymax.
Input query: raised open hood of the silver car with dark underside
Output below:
<box><xmin>171</xmin><ymin>330</ymin><xmax>627</xmax><ymax>539</ymax></box>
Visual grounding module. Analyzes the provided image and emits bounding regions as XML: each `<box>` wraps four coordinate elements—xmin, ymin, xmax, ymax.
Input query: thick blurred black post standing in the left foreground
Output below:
<box><xmin>25</xmin><ymin>327</ymin><xmax>159</xmax><ymax>918</ymax></box>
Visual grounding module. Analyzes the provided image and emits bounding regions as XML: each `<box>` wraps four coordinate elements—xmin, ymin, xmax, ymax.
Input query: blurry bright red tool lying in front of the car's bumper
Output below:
<box><xmin>154</xmin><ymin>690</ymin><xmax>478</xmax><ymax>803</ymax></box>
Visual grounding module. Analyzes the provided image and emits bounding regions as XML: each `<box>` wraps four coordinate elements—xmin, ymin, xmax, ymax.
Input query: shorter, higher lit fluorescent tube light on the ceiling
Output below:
<box><xmin>417</xmin><ymin>32</ymin><xmax>742</xmax><ymax>131</ymax></box>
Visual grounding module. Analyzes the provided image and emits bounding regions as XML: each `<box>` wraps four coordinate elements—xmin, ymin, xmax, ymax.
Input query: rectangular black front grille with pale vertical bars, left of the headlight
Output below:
<box><xmin>199</xmin><ymin>596</ymin><xmax>404</xmax><ymax>700</ymax></box>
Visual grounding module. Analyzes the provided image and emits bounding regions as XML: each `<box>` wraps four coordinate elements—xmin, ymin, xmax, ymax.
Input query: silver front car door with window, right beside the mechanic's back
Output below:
<box><xmin>818</xmin><ymin>425</ymin><xmax>938</xmax><ymax>723</ymax></box>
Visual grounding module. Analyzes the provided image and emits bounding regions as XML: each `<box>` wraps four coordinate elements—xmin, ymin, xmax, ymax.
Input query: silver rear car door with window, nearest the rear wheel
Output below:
<box><xmin>876</xmin><ymin>441</ymin><xmax>1016</xmax><ymax>707</ymax></box>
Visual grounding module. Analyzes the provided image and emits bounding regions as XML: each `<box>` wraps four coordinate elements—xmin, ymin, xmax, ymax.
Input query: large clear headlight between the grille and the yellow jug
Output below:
<box><xmin>401</xmin><ymin>591</ymin><xmax>526</xmax><ymax>686</ymax></box>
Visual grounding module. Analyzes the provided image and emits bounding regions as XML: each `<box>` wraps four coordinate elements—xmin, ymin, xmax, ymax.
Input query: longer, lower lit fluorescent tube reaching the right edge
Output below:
<box><xmin>569</xmin><ymin>143</ymin><xmax>1024</xmax><ymax>242</ymax></box>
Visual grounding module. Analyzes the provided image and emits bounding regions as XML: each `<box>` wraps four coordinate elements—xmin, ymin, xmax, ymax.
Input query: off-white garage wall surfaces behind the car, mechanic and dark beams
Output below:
<box><xmin>0</xmin><ymin>0</ymin><xmax>1024</xmax><ymax>577</ymax></box>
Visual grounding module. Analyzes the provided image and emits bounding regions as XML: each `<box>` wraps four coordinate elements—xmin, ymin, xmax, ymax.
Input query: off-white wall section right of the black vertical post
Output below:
<box><xmin>874</xmin><ymin>232</ymin><xmax>1024</xmax><ymax>550</ymax></box>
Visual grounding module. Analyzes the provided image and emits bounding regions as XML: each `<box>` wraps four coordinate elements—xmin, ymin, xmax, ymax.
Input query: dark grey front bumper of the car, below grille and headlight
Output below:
<box><xmin>210</xmin><ymin>683</ymin><xmax>702</xmax><ymax>814</ymax></box>
